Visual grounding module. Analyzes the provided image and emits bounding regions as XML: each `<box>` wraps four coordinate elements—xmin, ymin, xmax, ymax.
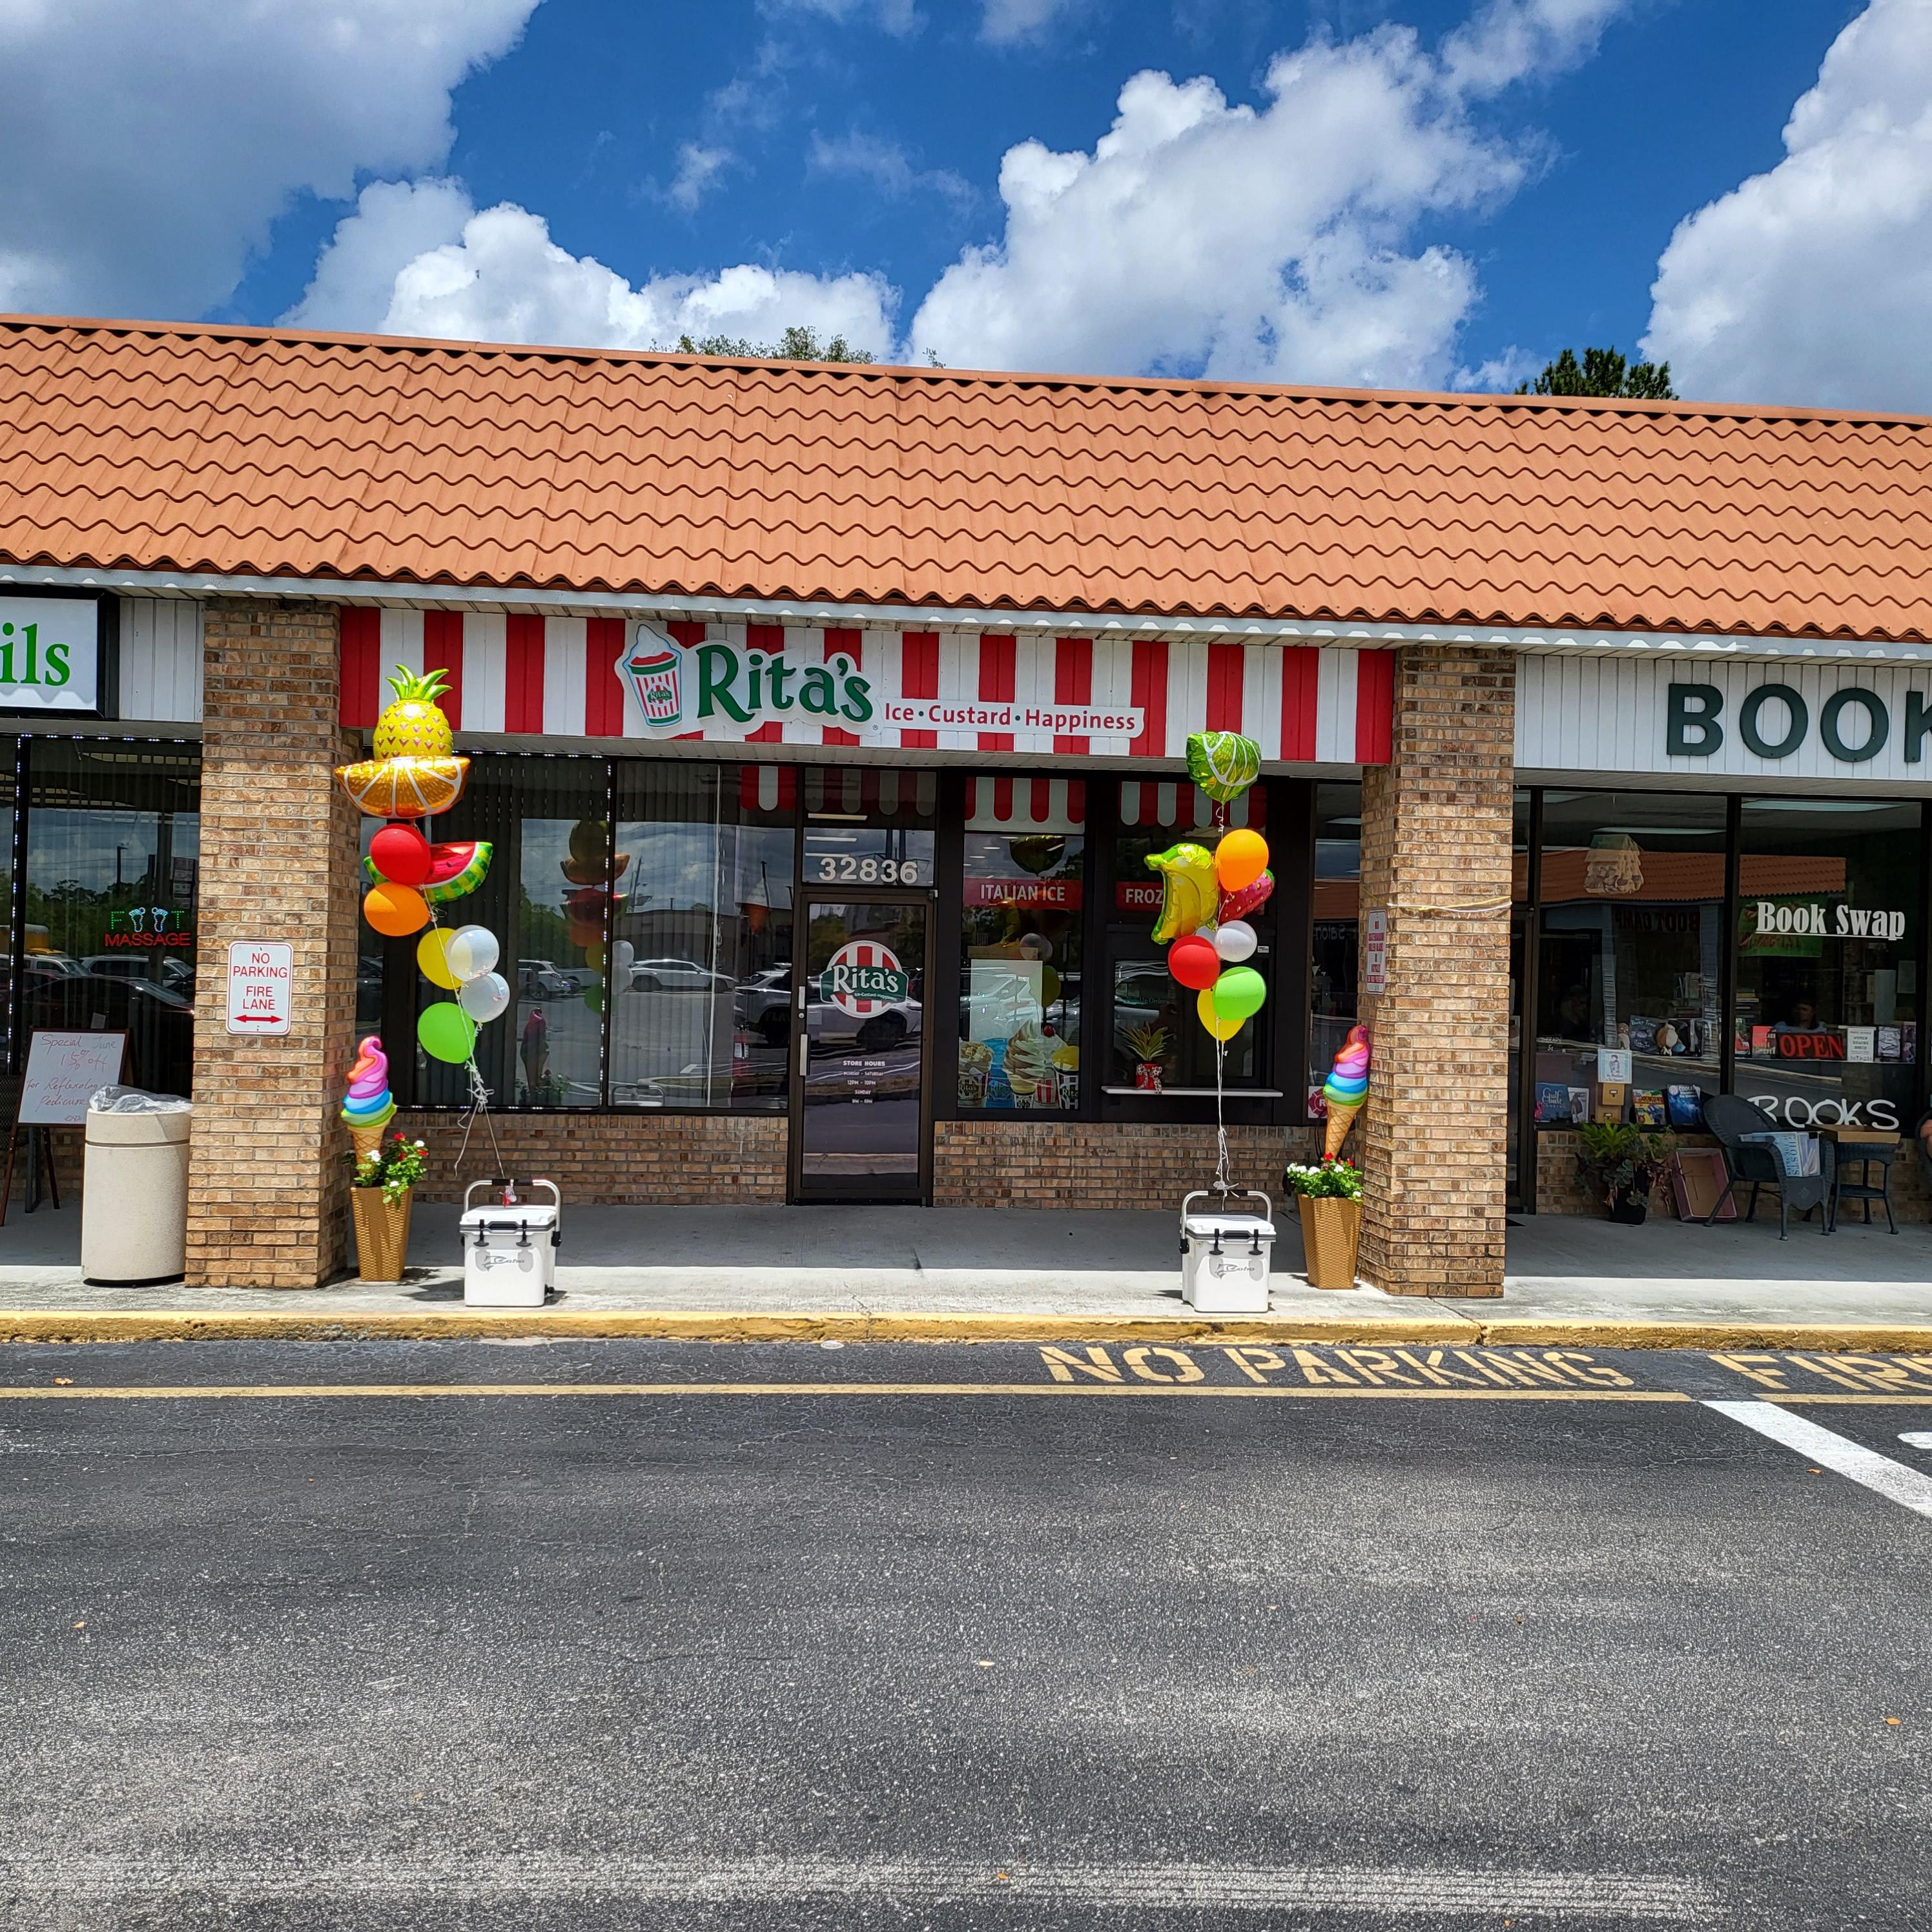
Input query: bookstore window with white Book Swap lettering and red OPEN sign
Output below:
<box><xmin>1735</xmin><ymin>798</ymin><xmax>1920</xmax><ymax>1128</ymax></box>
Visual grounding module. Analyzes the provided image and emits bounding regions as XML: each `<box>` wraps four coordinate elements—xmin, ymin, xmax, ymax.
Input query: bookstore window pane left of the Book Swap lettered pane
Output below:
<box><xmin>1536</xmin><ymin>790</ymin><xmax>1725</xmax><ymax>1126</ymax></box>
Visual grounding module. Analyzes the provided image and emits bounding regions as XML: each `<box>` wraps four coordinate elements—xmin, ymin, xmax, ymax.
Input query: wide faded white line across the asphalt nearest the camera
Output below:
<box><xmin>0</xmin><ymin>1849</ymin><xmax>1723</xmax><ymax>1926</ymax></box>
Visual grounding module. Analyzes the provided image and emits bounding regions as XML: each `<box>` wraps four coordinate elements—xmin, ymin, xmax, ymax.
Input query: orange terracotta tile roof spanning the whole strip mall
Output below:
<box><xmin>0</xmin><ymin>319</ymin><xmax>1932</xmax><ymax>639</ymax></box>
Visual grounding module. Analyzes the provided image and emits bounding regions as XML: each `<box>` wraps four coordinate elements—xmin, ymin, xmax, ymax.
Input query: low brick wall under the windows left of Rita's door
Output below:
<box><xmin>396</xmin><ymin>1113</ymin><xmax>786</xmax><ymax>1208</ymax></box>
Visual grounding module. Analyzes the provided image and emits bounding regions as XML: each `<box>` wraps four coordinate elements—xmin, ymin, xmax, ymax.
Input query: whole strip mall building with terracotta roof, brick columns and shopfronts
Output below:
<box><xmin>0</xmin><ymin>319</ymin><xmax>1932</xmax><ymax>1297</ymax></box>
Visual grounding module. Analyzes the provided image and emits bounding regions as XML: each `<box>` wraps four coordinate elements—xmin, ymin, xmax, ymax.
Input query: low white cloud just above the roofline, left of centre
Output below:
<box><xmin>286</xmin><ymin>181</ymin><xmax>896</xmax><ymax>356</ymax></box>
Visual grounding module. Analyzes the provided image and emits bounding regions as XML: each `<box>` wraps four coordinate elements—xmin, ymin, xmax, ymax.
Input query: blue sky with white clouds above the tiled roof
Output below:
<box><xmin>0</xmin><ymin>0</ymin><xmax>1932</xmax><ymax>411</ymax></box>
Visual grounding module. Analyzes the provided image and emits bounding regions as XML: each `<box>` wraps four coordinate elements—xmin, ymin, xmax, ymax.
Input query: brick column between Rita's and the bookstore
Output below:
<box><xmin>1356</xmin><ymin>645</ymin><xmax>1517</xmax><ymax>1295</ymax></box>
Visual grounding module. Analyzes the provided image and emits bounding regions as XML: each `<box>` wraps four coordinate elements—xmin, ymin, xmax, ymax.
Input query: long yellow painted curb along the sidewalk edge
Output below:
<box><xmin>11</xmin><ymin>1308</ymin><xmax>1932</xmax><ymax>1354</ymax></box>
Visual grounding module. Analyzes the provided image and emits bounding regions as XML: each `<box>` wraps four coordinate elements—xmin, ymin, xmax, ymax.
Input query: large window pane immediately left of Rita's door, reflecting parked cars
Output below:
<box><xmin>610</xmin><ymin>763</ymin><xmax>798</xmax><ymax>1111</ymax></box>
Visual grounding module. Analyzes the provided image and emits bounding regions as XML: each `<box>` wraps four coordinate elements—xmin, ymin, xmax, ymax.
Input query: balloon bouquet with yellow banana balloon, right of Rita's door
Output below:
<box><xmin>1147</xmin><ymin>730</ymin><xmax>1275</xmax><ymax>1194</ymax></box>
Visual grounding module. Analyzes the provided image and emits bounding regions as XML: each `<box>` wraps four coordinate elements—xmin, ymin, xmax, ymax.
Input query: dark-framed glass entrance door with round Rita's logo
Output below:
<box><xmin>792</xmin><ymin>896</ymin><xmax>931</xmax><ymax>1202</ymax></box>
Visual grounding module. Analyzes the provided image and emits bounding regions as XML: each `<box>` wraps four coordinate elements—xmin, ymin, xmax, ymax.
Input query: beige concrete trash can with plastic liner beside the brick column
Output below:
<box><xmin>81</xmin><ymin>1087</ymin><xmax>193</xmax><ymax>1287</ymax></box>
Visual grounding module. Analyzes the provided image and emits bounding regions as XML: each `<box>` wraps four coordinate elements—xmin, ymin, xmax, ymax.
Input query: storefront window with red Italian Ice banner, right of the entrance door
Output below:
<box><xmin>958</xmin><ymin>779</ymin><xmax>1086</xmax><ymax>1111</ymax></box>
